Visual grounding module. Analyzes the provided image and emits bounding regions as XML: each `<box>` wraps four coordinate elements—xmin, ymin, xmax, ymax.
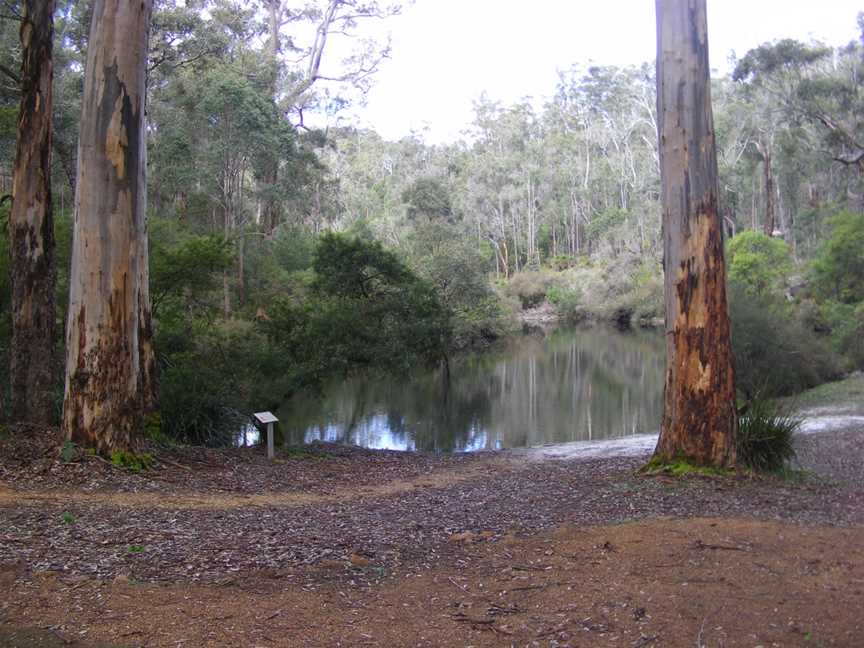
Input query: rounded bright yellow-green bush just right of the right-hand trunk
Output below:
<box><xmin>726</xmin><ymin>230</ymin><xmax>792</xmax><ymax>295</ymax></box>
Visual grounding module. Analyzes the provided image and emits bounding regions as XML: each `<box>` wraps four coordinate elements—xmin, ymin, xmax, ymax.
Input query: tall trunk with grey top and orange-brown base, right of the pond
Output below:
<box><xmin>655</xmin><ymin>0</ymin><xmax>737</xmax><ymax>467</ymax></box>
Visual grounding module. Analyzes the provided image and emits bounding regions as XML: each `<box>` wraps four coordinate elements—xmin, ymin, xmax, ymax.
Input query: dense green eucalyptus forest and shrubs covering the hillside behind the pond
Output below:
<box><xmin>0</xmin><ymin>0</ymin><xmax>864</xmax><ymax>444</ymax></box>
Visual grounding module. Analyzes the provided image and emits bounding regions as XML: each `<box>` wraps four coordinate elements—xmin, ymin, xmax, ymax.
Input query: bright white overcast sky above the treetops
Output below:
<box><xmin>340</xmin><ymin>0</ymin><xmax>864</xmax><ymax>143</ymax></box>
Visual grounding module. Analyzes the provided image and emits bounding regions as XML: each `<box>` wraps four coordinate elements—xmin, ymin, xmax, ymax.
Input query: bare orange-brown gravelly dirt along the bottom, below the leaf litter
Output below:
<box><xmin>0</xmin><ymin>518</ymin><xmax>864</xmax><ymax>647</ymax></box>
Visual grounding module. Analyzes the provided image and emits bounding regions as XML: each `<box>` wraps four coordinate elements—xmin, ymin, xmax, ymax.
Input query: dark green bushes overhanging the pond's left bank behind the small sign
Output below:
<box><xmin>160</xmin><ymin>234</ymin><xmax>452</xmax><ymax>445</ymax></box>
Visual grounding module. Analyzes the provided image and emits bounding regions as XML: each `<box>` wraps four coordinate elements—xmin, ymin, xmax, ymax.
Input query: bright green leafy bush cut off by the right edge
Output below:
<box><xmin>811</xmin><ymin>211</ymin><xmax>864</xmax><ymax>304</ymax></box>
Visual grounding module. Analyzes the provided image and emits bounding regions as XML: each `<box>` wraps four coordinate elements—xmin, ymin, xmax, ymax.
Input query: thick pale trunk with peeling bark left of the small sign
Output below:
<box><xmin>63</xmin><ymin>0</ymin><xmax>155</xmax><ymax>453</ymax></box>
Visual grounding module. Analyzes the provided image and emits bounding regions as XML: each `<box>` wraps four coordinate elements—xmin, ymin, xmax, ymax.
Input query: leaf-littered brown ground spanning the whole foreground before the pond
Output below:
<box><xmin>0</xmin><ymin>376</ymin><xmax>864</xmax><ymax>647</ymax></box>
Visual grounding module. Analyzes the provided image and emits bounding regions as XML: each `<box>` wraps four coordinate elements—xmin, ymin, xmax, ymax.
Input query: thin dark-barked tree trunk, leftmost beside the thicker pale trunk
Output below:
<box><xmin>9</xmin><ymin>0</ymin><xmax>56</xmax><ymax>424</ymax></box>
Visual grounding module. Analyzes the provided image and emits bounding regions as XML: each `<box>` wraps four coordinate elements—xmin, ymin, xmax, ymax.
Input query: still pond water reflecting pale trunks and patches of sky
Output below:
<box><xmin>278</xmin><ymin>328</ymin><xmax>664</xmax><ymax>452</ymax></box>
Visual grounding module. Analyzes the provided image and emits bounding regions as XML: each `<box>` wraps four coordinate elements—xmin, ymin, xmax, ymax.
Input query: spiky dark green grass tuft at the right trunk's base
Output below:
<box><xmin>736</xmin><ymin>395</ymin><xmax>801</xmax><ymax>472</ymax></box>
